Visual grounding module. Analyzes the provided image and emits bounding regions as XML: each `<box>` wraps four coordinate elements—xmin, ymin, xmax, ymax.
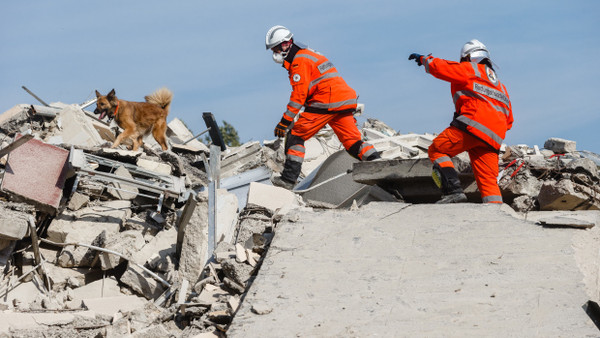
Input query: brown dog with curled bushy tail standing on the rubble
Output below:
<box><xmin>94</xmin><ymin>88</ymin><xmax>173</xmax><ymax>150</ymax></box>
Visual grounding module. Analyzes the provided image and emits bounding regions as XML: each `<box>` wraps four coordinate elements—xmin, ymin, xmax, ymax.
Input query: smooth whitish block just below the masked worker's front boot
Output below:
<box><xmin>247</xmin><ymin>182</ymin><xmax>300</xmax><ymax>214</ymax></box>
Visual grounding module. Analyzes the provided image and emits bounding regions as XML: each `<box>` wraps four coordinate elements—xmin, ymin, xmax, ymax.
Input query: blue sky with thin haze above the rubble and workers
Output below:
<box><xmin>0</xmin><ymin>0</ymin><xmax>600</xmax><ymax>153</ymax></box>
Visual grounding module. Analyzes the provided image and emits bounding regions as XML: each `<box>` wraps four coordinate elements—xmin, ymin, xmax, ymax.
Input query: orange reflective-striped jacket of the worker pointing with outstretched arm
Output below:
<box><xmin>421</xmin><ymin>56</ymin><xmax>513</xmax><ymax>151</ymax></box>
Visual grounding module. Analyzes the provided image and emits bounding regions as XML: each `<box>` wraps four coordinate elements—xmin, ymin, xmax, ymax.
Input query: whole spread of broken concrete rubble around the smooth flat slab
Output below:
<box><xmin>0</xmin><ymin>95</ymin><xmax>600</xmax><ymax>337</ymax></box>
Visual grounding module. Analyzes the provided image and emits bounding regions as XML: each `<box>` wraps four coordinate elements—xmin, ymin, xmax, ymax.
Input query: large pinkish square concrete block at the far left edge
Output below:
<box><xmin>1</xmin><ymin>135</ymin><xmax>69</xmax><ymax>213</ymax></box>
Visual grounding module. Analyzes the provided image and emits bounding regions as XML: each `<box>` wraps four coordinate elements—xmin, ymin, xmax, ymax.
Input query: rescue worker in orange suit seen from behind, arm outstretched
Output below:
<box><xmin>408</xmin><ymin>39</ymin><xmax>513</xmax><ymax>203</ymax></box>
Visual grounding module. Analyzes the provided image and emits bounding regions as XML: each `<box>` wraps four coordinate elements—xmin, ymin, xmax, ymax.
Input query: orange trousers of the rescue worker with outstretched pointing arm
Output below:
<box><xmin>429</xmin><ymin>126</ymin><xmax>502</xmax><ymax>203</ymax></box>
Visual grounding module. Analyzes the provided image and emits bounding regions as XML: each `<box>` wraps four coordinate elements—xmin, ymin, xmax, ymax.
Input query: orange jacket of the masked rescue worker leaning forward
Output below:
<box><xmin>283</xmin><ymin>44</ymin><xmax>357</xmax><ymax>121</ymax></box>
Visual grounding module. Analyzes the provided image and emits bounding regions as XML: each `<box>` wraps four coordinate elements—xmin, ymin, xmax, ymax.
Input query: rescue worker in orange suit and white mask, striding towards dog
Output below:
<box><xmin>265</xmin><ymin>26</ymin><xmax>380</xmax><ymax>189</ymax></box>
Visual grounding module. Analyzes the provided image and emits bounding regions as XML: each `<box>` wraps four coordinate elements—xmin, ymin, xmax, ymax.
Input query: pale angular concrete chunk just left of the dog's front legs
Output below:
<box><xmin>47</xmin><ymin>105</ymin><xmax>105</xmax><ymax>147</ymax></box>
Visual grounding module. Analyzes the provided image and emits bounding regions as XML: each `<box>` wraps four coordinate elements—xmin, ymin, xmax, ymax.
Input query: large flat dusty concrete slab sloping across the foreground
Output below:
<box><xmin>227</xmin><ymin>202</ymin><xmax>600</xmax><ymax>337</ymax></box>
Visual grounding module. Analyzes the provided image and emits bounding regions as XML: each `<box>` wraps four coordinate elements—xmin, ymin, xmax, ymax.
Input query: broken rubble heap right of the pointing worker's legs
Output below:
<box><xmin>499</xmin><ymin>138</ymin><xmax>600</xmax><ymax>212</ymax></box>
